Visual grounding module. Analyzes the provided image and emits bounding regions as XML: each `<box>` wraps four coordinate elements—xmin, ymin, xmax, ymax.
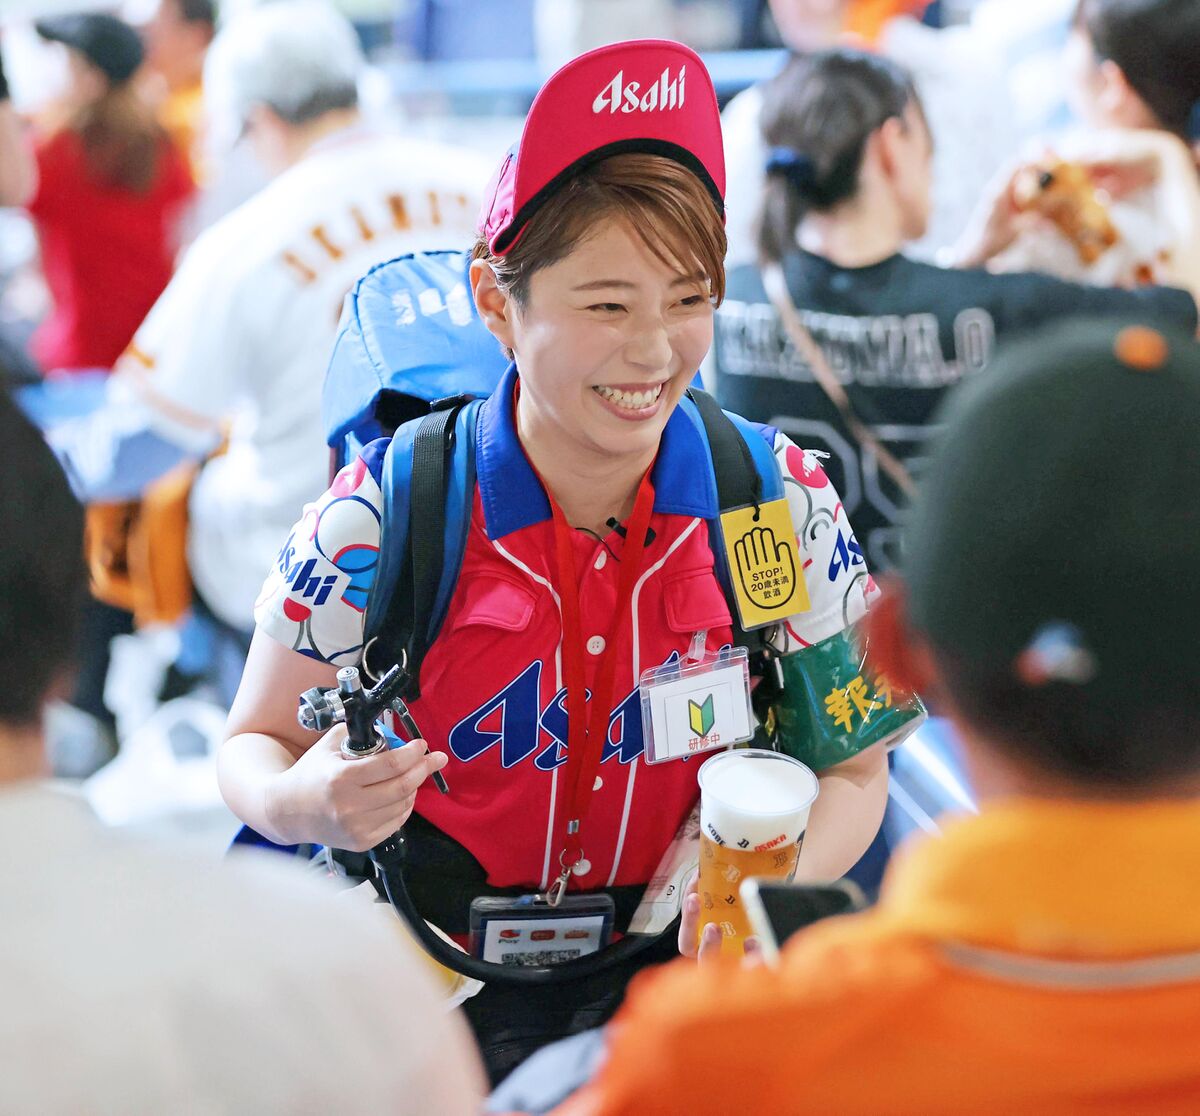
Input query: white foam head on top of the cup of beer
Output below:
<box><xmin>698</xmin><ymin>749</ymin><xmax>817</xmax><ymax>850</ymax></box>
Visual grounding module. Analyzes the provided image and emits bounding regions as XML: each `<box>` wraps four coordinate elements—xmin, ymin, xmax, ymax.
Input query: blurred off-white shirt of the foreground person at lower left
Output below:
<box><xmin>0</xmin><ymin>785</ymin><xmax>484</xmax><ymax>1116</ymax></box>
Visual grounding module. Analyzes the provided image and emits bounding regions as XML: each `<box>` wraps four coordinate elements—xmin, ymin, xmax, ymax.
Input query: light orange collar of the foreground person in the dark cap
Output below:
<box><xmin>877</xmin><ymin>799</ymin><xmax>1200</xmax><ymax>959</ymax></box>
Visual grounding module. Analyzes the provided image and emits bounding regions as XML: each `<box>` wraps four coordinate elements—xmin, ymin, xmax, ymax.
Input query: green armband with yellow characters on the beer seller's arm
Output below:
<box><xmin>764</xmin><ymin>628</ymin><xmax>928</xmax><ymax>772</ymax></box>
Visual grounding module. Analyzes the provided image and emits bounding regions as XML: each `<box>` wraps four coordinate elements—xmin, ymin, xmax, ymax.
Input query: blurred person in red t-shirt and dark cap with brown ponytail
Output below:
<box><xmin>8</xmin><ymin>14</ymin><xmax>193</xmax><ymax>372</ymax></box>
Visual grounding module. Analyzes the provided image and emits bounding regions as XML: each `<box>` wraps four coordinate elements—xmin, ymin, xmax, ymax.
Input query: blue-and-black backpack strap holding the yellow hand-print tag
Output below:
<box><xmin>683</xmin><ymin>388</ymin><xmax>786</xmax><ymax>654</ymax></box>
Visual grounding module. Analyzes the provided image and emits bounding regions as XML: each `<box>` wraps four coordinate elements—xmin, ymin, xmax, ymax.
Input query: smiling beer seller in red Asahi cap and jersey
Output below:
<box><xmin>220</xmin><ymin>32</ymin><xmax>916</xmax><ymax>1079</ymax></box>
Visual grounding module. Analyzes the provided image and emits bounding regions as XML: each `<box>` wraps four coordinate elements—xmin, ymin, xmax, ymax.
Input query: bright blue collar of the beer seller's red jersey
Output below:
<box><xmin>475</xmin><ymin>364</ymin><xmax>718</xmax><ymax>539</ymax></box>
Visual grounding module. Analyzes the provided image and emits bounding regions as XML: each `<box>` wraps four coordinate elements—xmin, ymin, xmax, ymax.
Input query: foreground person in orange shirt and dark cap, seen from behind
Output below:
<box><xmin>556</xmin><ymin>320</ymin><xmax>1200</xmax><ymax>1116</ymax></box>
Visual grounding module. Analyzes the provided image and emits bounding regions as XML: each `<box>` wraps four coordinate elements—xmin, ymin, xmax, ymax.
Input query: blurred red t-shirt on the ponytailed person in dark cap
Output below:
<box><xmin>29</xmin><ymin>130</ymin><xmax>194</xmax><ymax>371</ymax></box>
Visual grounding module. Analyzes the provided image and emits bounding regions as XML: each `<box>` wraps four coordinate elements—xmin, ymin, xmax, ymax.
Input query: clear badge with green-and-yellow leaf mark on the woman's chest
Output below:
<box><xmin>638</xmin><ymin>632</ymin><xmax>754</xmax><ymax>763</ymax></box>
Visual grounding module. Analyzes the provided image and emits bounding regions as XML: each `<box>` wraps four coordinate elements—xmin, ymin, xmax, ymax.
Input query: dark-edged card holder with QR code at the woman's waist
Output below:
<box><xmin>469</xmin><ymin>895</ymin><xmax>616</xmax><ymax>966</ymax></box>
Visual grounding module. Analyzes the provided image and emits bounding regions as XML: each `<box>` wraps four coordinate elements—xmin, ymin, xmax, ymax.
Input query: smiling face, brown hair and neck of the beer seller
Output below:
<box><xmin>472</xmin><ymin>200</ymin><xmax>724</xmax><ymax>534</ymax></box>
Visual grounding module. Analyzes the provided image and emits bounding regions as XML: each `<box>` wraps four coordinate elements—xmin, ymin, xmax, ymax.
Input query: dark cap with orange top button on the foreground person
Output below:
<box><xmin>904</xmin><ymin>322</ymin><xmax>1200</xmax><ymax>708</ymax></box>
